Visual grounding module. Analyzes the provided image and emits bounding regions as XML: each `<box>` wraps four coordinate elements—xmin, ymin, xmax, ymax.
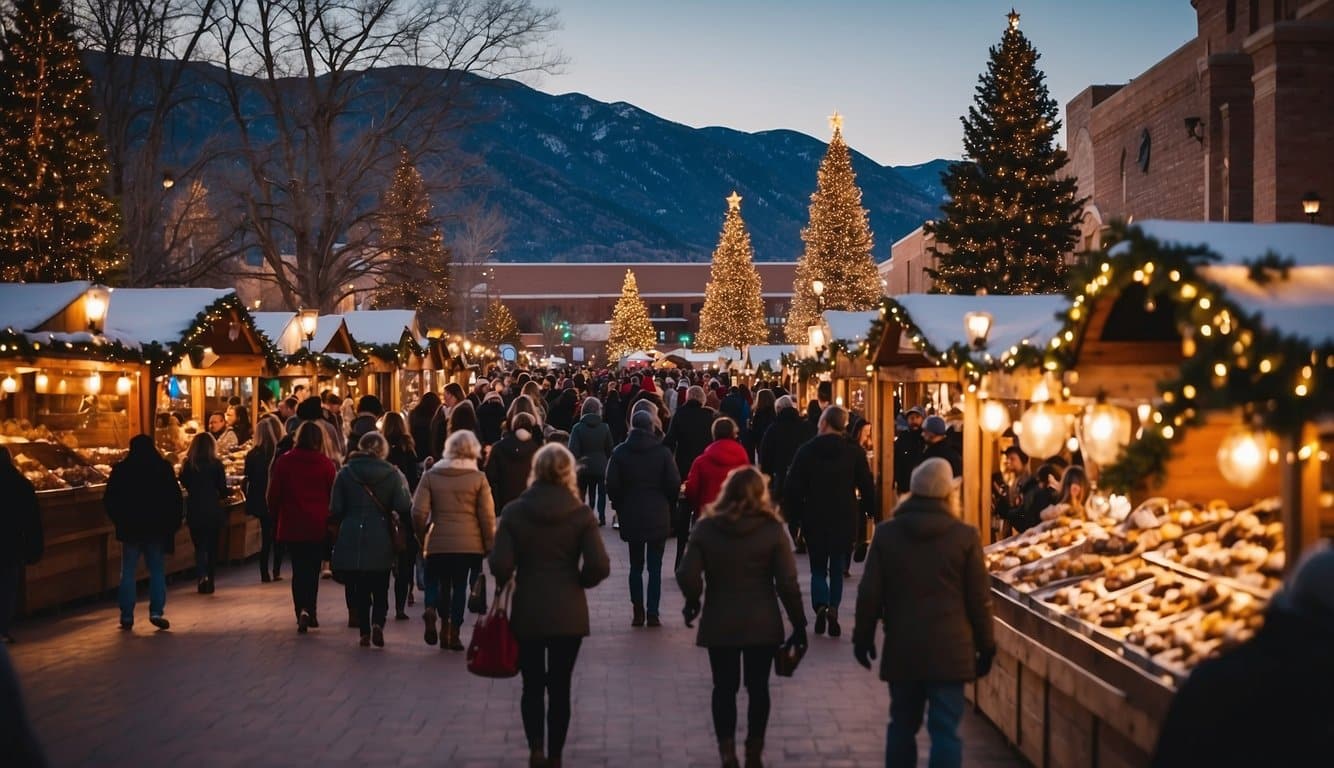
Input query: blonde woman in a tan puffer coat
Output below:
<box><xmin>412</xmin><ymin>431</ymin><xmax>496</xmax><ymax>651</ymax></box>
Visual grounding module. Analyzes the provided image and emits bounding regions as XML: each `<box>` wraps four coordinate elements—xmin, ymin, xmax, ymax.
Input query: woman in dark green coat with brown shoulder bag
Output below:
<box><xmin>329</xmin><ymin>432</ymin><xmax>412</xmax><ymax>648</ymax></box>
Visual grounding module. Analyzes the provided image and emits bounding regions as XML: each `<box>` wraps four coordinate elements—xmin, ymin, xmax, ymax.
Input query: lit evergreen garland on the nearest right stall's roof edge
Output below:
<box><xmin>1045</xmin><ymin>221</ymin><xmax>1334</xmax><ymax>489</ymax></box>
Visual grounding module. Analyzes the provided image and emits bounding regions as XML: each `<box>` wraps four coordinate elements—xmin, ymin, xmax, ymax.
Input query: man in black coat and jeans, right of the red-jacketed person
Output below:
<box><xmin>783</xmin><ymin>405</ymin><xmax>875</xmax><ymax>637</ymax></box>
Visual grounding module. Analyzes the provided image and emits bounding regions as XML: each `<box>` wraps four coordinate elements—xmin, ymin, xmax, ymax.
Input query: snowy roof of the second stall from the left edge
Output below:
<box><xmin>107</xmin><ymin>288</ymin><xmax>236</xmax><ymax>347</ymax></box>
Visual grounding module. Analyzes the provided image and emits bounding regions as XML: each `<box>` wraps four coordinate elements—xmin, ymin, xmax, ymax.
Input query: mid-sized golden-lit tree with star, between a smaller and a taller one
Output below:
<box><xmin>695</xmin><ymin>191</ymin><xmax>768</xmax><ymax>349</ymax></box>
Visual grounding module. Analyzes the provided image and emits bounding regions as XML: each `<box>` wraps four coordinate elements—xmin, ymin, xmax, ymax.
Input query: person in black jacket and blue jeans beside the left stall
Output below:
<box><xmin>103</xmin><ymin>435</ymin><xmax>183</xmax><ymax>629</ymax></box>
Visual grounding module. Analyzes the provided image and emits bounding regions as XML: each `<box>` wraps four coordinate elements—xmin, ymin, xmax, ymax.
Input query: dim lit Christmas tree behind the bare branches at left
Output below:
<box><xmin>372</xmin><ymin>151</ymin><xmax>450</xmax><ymax>325</ymax></box>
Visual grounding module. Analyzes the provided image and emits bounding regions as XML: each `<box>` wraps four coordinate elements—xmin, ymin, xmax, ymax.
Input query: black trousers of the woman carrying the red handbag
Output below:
<box><xmin>519</xmin><ymin>637</ymin><xmax>583</xmax><ymax>757</ymax></box>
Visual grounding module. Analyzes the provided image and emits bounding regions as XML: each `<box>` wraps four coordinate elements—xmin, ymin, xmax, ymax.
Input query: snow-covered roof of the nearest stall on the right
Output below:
<box><xmin>1110</xmin><ymin>221</ymin><xmax>1334</xmax><ymax>345</ymax></box>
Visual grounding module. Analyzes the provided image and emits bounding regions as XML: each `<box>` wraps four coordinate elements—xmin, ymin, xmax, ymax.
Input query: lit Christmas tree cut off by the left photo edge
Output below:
<box><xmin>0</xmin><ymin>0</ymin><xmax>121</xmax><ymax>281</ymax></box>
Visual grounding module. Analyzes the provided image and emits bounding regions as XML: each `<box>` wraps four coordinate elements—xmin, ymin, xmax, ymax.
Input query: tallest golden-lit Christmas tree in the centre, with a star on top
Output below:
<box><xmin>784</xmin><ymin>112</ymin><xmax>880</xmax><ymax>344</ymax></box>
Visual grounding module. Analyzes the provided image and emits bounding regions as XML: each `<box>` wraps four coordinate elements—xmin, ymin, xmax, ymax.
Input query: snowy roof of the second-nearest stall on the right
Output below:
<box><xmin>894</xmin><ymin>293</ymin><xmax>1070</xmax><ymax>365</ymax></box>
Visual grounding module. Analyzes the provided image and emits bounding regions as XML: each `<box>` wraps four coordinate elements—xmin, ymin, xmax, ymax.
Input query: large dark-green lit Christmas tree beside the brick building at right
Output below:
<box><xmin>926</xmin><ymin>11</ymin><xmax>1083</xmax><ymax>293</ymax></box>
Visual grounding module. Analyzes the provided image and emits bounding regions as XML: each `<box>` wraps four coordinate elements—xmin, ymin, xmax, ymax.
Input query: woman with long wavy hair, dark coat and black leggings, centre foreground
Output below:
<box><xmin>676</xmin><ymin>467</ymin><xmax>806</xmax><ymax>765</ymax></box>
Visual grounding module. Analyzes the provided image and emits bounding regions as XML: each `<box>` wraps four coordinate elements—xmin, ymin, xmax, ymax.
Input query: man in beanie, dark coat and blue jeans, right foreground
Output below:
<box><xmin>852</xmin><ymin>459</ymin><xmax>996</xmax><ymax>768</ymax></box>
